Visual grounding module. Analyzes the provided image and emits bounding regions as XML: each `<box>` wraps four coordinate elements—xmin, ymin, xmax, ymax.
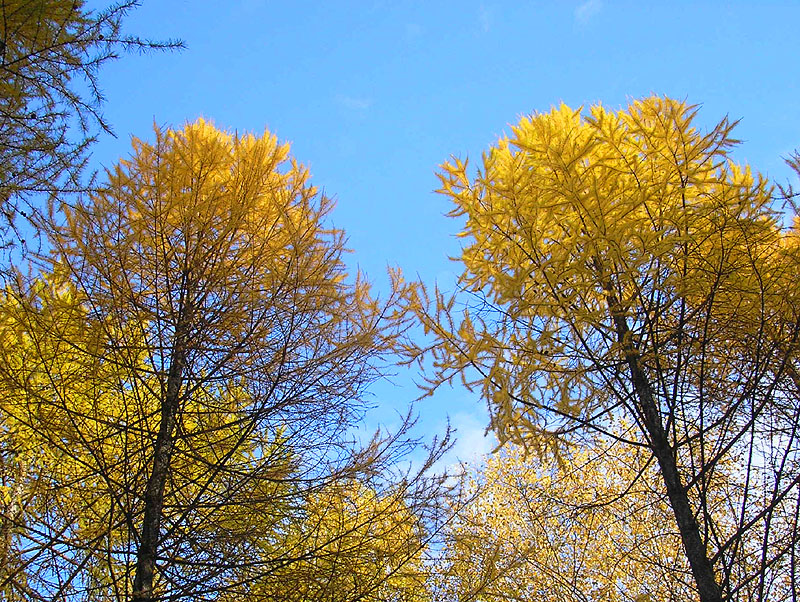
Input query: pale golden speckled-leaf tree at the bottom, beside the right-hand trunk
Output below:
<box><xmin>435</xmin><ymin>440</ymin><xmax>692</xmax><ymax>602</ymax></box>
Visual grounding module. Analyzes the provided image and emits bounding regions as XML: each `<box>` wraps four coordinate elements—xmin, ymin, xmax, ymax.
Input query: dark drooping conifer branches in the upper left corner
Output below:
<box><xmin>0</xmin><ymin>0</ymin><xmax>182</xmax><ymax>254</ymax></box>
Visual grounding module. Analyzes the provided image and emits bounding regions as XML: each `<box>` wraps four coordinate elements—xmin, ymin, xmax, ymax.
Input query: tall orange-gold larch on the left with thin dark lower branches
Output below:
<box><xmin>0</xmin><ymin>120</ymin><xmax>450</xmax><ymax>602</ymax></box>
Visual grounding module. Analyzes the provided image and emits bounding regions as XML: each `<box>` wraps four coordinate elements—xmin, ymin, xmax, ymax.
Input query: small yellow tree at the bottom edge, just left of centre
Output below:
<box><xmin>239</xmin><ymin>481</ymin><xmax>428</xmax><ymax>602</ymax></box>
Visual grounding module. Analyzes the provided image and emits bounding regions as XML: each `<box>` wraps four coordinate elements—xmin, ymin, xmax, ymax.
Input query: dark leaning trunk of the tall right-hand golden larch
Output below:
<box><xmin>607</xmin><ymin>289</ymin><xmax>722</xmax><ymax>602</ymax></box>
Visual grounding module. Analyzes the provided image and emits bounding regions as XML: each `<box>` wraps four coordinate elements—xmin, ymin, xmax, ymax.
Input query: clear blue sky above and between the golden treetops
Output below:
<box><xmin>89</xmin><ymin>0</ymin><xmax>800</xmax><ymax>459</ymax></box>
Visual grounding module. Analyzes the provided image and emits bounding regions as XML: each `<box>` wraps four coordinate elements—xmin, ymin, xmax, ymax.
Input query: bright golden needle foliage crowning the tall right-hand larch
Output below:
<box><xmin>411</xmin><ymin>97</ymin><xmax>779</xmax><ymax>450</ymax></box>
